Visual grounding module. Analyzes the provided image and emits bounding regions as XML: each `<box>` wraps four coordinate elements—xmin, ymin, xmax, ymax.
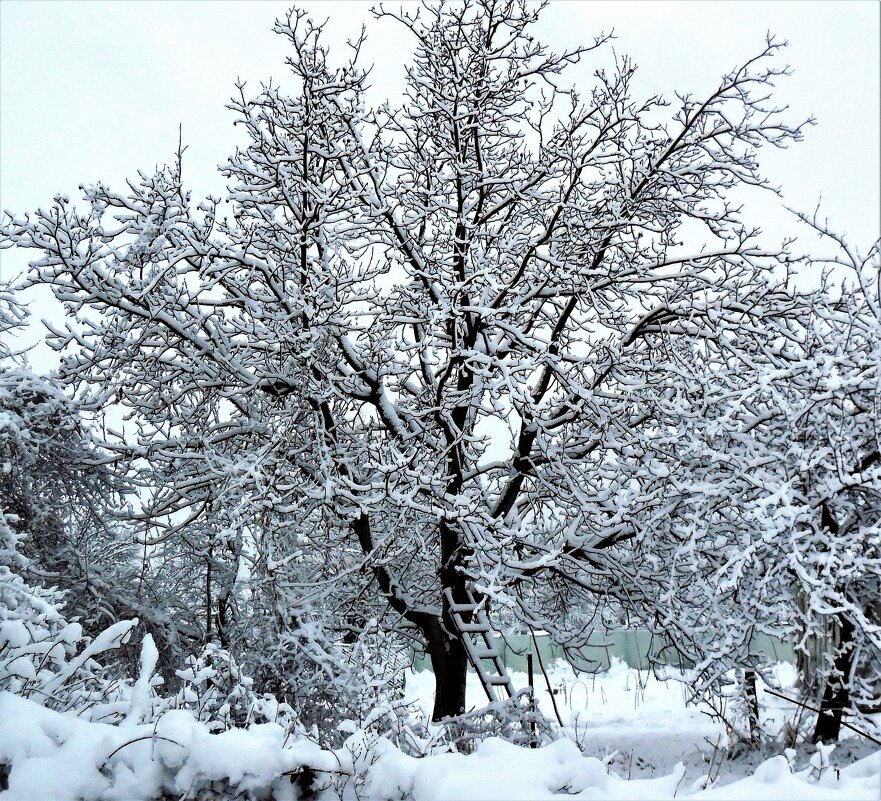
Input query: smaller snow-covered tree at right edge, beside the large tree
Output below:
<box><xmin>585</xmin><ymin>217</ymin><xmax>881</xmax><ymax>740</ymax></box>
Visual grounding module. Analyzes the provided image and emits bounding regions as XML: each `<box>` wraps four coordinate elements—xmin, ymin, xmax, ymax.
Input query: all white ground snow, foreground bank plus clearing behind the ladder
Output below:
<box><xmin>0</xmin><ymin>652</ymin><xmax>881</xmax><ymax>801</ymax></box>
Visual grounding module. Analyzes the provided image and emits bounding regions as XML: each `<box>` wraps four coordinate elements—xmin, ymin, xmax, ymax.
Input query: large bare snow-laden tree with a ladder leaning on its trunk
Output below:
<box><xmin>2</xmin><ymin>0</ymin><xmax>801</xmax><ymax>718</ymax></box>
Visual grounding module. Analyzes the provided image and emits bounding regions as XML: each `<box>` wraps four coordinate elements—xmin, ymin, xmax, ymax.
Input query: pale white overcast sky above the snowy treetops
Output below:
<box><xmin>0</xmin><ymin>0</ymin><xmax>881</xmax><ymax>369</ymax></box>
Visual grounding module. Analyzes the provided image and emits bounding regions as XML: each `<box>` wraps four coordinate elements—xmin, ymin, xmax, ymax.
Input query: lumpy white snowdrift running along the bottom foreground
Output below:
<box><xmin>0</xmin><ymin>692</ymin><xmax>881</xmax><ymax>801</ymax></box>
